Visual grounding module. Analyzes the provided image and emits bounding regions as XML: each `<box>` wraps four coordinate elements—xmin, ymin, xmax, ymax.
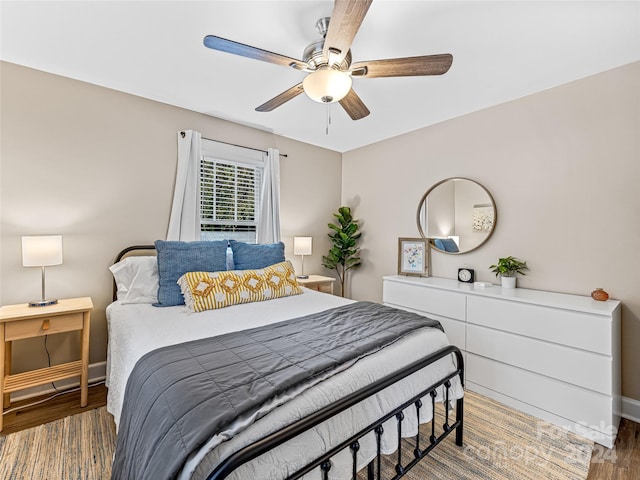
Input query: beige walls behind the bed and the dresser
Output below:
<box><xmin>0</xmin><ymin>63</ymin><xmax>640</xmax><ymax>399</ymax></box>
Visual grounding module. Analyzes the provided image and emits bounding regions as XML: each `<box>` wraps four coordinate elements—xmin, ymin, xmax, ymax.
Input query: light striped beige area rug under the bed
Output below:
<box><xmin>0</xmin><ymin>391</ymin><xmax>593</xmax><ymax>480</ymax></box>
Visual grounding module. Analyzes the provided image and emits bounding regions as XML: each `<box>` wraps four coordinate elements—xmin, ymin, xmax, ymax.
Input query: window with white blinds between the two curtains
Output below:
<box><xmin>200</xmin><ymin>140</ymin><xmax>264</xmax><ymax>243</ymax></box>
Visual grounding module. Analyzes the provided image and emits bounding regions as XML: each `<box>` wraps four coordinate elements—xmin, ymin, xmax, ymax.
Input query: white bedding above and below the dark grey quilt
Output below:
<box><xmin>107</xmin><ymin>289</ymin><xmax>463</xmax><ymax>479</ymax></box>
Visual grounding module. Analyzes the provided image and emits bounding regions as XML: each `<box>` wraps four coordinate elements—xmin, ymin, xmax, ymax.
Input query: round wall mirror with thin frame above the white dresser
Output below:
<box><xmin>417</xmin><ymin>178</ymin><xmax>498</xmax><ymax>254</ymax></box>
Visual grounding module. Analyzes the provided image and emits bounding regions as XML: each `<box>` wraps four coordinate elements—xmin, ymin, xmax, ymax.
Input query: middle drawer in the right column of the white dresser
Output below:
<box><xmin>467</xmin><ymin>325</ymin><xmax>613</xmax><ymax>395</ymax></box>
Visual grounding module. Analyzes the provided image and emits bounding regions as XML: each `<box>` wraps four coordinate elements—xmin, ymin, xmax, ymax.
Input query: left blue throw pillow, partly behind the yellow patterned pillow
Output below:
<box><xmin>153</xmin><ymin>240</ymin><xmax>227</xmax><ymax>307</ymax></box>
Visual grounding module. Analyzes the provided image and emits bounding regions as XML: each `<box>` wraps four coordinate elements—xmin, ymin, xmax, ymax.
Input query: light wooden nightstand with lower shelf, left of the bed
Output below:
<box><xmin>0</xmin><ymin>297</ymin><xmax>93</xmax><ymax>431</ymax></box>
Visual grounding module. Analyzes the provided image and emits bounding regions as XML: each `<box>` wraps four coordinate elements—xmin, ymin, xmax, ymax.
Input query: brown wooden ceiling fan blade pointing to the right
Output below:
<box><xmin>351</xmin><ymin>53</ymin><xmax>453</xmax><ymax>78</ymax></box>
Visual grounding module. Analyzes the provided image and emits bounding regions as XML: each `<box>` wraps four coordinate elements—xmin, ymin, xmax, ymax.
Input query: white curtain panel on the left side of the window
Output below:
<box><xmin>167</xmin><ymin>130</ymin><xmax>202</xmax><ymax>241</ymax></box>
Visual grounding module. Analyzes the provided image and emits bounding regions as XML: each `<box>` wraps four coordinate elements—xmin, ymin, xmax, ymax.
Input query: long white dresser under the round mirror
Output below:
<box><xmin>383</xmin><ymin>275</ymin><xmax>621</xmax><ymax>448</ymax></box>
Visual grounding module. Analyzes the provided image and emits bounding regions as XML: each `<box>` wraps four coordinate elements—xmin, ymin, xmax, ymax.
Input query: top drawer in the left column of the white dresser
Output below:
<box><xmin>383</xmin><ymin>280</ymin><xmax>466</xmax><ymax>321</ymax></box>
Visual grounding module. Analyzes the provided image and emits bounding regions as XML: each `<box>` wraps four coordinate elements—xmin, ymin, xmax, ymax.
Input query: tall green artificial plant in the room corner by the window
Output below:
<box><xmin>322</xmin><ymin>207</ymin><xmax>362</xmax><ymax>297</ymax></box>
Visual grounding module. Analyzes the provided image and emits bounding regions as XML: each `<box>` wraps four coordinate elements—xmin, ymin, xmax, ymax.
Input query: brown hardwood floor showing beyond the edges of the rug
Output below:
<box><xmin>0</xmin><ymin>385</ymin><xmax>640</xmax><ymax>480</ymax></box>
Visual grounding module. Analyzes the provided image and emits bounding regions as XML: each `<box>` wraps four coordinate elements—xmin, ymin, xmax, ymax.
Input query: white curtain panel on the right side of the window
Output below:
<box><xmin>256</xmin><ymin>148</ymin><xmax>280</xmax><ymax>243</ymax></box>
